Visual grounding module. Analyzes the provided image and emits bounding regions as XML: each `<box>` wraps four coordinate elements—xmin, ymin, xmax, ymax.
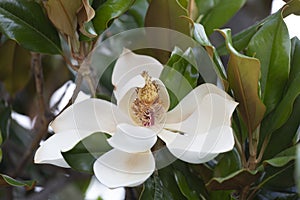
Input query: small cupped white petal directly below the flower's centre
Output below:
<box><xmin>107</xmin><ymin>124</ymin><xmax>157</xmax><ymax>153</ymax></box>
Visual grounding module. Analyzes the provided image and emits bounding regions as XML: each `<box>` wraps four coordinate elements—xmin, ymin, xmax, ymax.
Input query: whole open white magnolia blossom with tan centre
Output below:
<box><xmin>35</xmin><ymin>49</ymin><xmax>237</xmax><ymax>188</ymax></box>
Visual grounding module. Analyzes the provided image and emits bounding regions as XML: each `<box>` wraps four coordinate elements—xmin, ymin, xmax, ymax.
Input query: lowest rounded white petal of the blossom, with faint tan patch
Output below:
<box><xmin>94</xmin><ymin>149</ymin><xmax>155</xmax><ymax>188</ymax></box>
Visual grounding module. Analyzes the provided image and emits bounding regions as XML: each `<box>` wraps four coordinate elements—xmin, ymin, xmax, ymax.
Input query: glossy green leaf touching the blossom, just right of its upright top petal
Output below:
<box><xmin>160</xmin><ymin>48</ymin><xmax>199</xmax><ymax>109</ymax></box>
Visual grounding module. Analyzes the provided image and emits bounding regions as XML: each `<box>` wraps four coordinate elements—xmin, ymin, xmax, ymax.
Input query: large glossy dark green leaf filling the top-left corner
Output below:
<box><xmin>0</xmin><ymin>0</ymin><xmax>62</xmax><ymax>54</ymax></box>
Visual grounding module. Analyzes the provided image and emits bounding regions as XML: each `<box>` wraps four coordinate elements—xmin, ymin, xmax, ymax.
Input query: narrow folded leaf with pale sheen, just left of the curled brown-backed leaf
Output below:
<box><xmin>194</xmin><ymin>23</ymin><xmax>228</xmax><ymax>90</ymax></box>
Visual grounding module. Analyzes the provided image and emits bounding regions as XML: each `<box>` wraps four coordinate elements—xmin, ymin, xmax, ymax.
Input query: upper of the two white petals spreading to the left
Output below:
<box><xmin>51</xmin><ymin>99</ymin><xmax>130</xmax><ymax>133</ymax></box>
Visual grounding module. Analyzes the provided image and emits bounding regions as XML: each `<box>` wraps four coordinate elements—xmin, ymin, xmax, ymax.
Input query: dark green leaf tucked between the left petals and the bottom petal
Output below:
<box><xmin>62</xmin><ymin>133</ymin><xmax>112</xmax><ymax>174</ymax></box>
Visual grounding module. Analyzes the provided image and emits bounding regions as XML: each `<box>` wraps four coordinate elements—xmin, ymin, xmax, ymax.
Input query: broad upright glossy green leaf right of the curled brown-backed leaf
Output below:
<box><xmin>247</xmin><ymin>11</ymin><xmax>291</xmax><ymax>114</ymax></box>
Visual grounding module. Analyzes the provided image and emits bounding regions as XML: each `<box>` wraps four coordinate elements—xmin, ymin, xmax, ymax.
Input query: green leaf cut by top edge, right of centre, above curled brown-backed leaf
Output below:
<box><xmin>198</xmin><ymin>0</ymin><xmax>246</xmax><ymax>35</ymax></box>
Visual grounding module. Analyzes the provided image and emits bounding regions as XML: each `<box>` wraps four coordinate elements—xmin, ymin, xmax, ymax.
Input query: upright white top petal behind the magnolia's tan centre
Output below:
<box><xmin>112</xmin><ymin>49</ymin><xmax>163</xmax><ymax>101</ymax></box>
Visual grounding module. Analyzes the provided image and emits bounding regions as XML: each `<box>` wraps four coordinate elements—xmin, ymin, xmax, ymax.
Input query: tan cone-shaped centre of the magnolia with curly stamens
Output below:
<box><xmin>131</xmin><ymin>71</ymin><xmax>164</xmax><ymax>127</ymax></box>
